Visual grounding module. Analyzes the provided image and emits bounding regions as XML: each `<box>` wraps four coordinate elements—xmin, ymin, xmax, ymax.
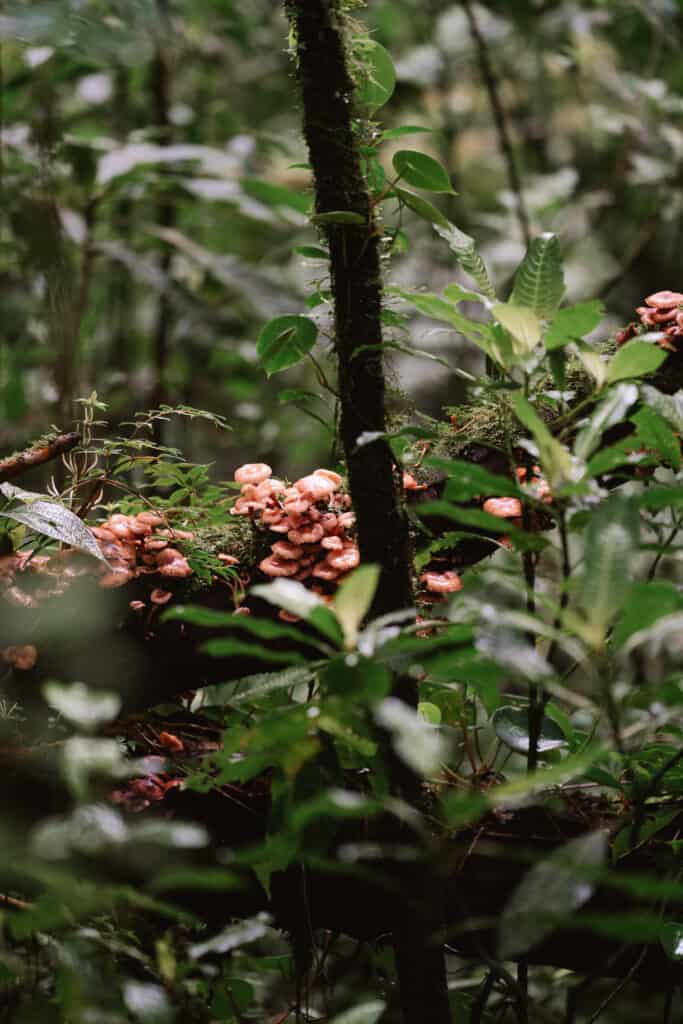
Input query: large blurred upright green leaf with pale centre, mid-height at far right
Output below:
<box><xmin>579</xmin><ymin>494</ymin><xmax>640</xmax><ymax>643</ymax></box>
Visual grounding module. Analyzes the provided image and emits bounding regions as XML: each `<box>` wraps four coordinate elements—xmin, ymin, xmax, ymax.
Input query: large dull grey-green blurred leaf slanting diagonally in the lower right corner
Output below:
<box><xmin>498</xmin><ymin>830</ymin><xmax>608</xmax><ymax>959</ymax></box>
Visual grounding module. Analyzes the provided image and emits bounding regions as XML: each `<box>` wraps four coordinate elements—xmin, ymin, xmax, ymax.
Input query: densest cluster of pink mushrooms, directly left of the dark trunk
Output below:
<box><xmin>230</xmin><ymin>462</ymin><xmax>360</xmax><ymax>597</ymax></box>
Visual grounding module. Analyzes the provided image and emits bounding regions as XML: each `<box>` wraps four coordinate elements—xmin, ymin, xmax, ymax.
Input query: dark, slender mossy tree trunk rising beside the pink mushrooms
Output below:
<box><xmin>286</xmin><ymin>0</ymin><xmax>451</xmax><ymax>1024</ymax></box>
